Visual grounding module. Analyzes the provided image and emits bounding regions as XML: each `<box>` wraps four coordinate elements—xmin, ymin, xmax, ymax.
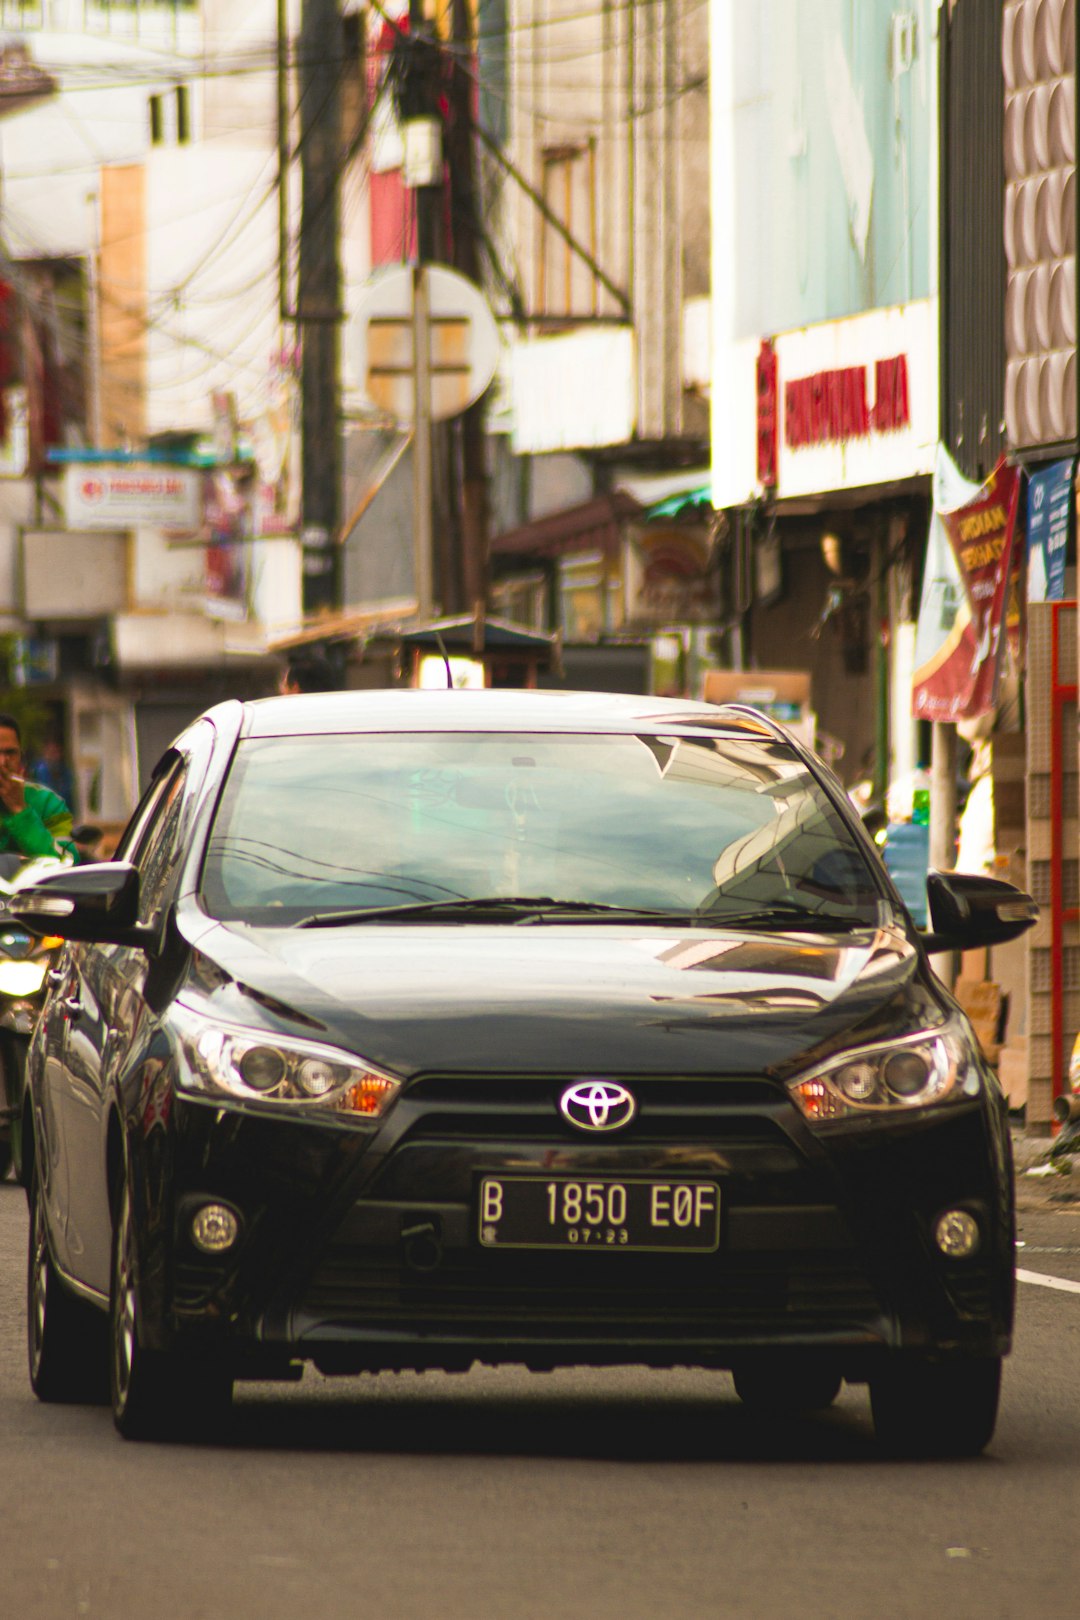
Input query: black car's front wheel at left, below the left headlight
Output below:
<box><xmin>108</xmin><ymin>1183</ymin><xmax>233</xmax><ymax>1440</ymax></box>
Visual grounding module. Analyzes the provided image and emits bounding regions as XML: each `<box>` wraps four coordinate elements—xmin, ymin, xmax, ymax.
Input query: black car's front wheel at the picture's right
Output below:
<box><xmin>870</xmin><ymin>1356</ymin><xmax>1001</xmax><ymax>1456</ymax></box>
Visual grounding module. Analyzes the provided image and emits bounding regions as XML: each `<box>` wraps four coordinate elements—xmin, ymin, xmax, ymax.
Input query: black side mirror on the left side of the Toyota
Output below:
<box><xmin>8</xmin><ymin>860</ymin><xmax>157</xmax><ymax>946</ymax></box>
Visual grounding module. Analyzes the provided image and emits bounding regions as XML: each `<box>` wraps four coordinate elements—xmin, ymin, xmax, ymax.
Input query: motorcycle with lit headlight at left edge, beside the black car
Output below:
<box><xmin>0</xmin><ymin>854</ymin><xmax>66</xmax><ymax>1181</ymax></box>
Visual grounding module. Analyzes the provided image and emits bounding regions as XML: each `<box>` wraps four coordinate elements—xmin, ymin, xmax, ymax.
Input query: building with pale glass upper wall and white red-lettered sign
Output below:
<box><xmin>711</xmin><ymin>0</ymin><xmax>939</xmax><ymax>792</ymax></box>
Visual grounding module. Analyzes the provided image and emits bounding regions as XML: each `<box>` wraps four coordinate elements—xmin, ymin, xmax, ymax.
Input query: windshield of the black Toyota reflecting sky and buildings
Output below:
<box><xmin>202</xmin><ymin>732</ymin><xmax>884</xmax><ymax>927</ymax></box>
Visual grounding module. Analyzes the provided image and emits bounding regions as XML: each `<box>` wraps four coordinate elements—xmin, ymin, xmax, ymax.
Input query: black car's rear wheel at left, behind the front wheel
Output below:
<box><xmin>26</xmin><ymin>1175</ymin><xmax>108</xmax><ymax>1405</ymax></box>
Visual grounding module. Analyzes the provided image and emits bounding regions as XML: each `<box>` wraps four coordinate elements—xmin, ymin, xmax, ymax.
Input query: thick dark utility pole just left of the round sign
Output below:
<box><xmin>296</xmin><ymin>0</ymin><xmax>343</xmax><ymax>612</ymax></box>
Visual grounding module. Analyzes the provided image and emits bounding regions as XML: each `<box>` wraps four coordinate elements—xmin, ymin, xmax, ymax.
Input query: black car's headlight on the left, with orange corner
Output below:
<box><xmin>181</xmin><ymin>1019</ymin><xmax>402</xmax><ymax>1119</ymax></box>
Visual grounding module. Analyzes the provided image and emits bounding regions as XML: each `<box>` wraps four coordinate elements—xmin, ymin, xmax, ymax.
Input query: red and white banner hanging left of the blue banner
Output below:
<box><xmin>912</xmin><ymin>450</ymin><xmax>1022</xmax><ymax>721</ymax></box>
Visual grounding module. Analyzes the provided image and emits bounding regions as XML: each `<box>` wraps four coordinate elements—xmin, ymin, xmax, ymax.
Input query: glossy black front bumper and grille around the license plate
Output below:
<box><xmin>152</xmin><ymin>1077</ymin><xmax>1012</xmax><ymax>1377</ymax></box>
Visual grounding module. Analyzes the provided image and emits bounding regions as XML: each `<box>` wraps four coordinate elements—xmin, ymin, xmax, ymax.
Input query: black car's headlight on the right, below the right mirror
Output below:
<box><xmin>787</xmin><ymin>1024</ymin><xmax>981</xmax><ymax>1124</ymax></box>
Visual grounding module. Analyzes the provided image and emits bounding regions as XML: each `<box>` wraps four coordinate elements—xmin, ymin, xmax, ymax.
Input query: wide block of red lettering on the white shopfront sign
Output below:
<box><xmin>784</xmin><ymin>355</ymin><xmax>912</xmax><ymax>450</ymax></box>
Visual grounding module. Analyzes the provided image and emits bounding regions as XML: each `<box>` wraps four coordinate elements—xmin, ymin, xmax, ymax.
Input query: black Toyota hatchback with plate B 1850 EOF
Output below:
<box><xmin>15</xmin><ymin>690</ymin><xmax>1035</xmax><ymax>1453</ymax></box>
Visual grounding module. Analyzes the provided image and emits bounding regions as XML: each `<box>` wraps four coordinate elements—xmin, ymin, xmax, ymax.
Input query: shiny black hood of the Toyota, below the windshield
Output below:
<box><xmin>185</xmin><ymin>925</ymin><xmax>928</xmax><ymax>1076</ymax></box>
